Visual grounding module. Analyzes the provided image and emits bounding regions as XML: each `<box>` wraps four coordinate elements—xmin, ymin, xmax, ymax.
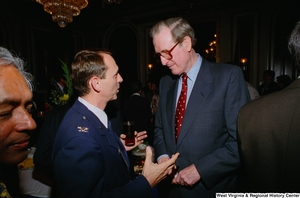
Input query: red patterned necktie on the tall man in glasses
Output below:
<box><xmin>175</xmin><ymin>73</ymin><xmax>188</xmax><ymax>142</ymax></box>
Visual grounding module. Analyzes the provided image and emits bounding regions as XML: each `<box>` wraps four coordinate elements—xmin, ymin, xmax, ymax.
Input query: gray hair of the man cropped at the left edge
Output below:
<box><xmin>0</xmin><ymin>47</ymin><xmax>33</xmax><ymax>91</ymax></box>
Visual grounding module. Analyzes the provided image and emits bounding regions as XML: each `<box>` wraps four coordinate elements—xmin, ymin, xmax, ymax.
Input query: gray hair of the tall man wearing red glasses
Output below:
<box><xmin>150</xmin><ymin>17</ymin><xmax>197</xmax><ymax>46</ymax></box>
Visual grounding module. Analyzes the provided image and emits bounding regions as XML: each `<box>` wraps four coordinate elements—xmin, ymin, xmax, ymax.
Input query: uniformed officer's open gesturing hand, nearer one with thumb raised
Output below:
<box><xmin>142</xmin><ymin>146</ymin><xmax>179</xmax><ymax>187</ymax></box>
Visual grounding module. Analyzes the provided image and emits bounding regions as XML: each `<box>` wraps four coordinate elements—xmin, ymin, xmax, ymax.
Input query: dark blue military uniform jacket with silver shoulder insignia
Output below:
<box><xmin>52</xmin><ymin>100</ymin><xmax>152</xmax><ymax>198</ymax></box>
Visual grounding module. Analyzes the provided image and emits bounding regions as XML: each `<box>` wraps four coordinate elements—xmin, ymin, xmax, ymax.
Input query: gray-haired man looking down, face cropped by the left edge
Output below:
<box><xmin>0</xmin><ymin>47</ymin><xmax>36</xmax><ymax>197</ymax></box>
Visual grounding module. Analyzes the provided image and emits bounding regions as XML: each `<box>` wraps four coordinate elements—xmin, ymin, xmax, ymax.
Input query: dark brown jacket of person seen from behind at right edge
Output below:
<box><xmin>238</xmin><ymin>79</ymin><xmax>300</xmax><ymax>192</ymax></box>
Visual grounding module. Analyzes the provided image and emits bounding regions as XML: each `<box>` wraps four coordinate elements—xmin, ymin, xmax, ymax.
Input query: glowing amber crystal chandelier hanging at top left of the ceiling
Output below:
<box><xmin>36</xmin><ymin>0</ymin><xmax>88</xmax><ymax>28</ymax></box>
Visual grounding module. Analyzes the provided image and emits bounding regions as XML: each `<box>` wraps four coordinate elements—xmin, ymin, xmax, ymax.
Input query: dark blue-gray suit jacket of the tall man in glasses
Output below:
<box><xmin>154</xmin><ymin>59</ymin><xmax>249</xmax><ymax>198</ymax></box>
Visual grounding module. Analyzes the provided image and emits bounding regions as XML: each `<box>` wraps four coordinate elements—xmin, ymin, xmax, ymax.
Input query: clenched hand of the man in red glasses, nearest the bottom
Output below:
<box><xmin>172</xmin><ymin>164</ymin><xmax>201</xmax><ymax>186</ymax></box>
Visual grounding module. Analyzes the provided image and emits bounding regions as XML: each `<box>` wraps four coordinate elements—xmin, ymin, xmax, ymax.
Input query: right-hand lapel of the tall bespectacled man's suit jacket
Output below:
<box><xmin>177</xmin><ymin>59</ymin><xmax>212</xmax><ymax>146</ymax></box>
